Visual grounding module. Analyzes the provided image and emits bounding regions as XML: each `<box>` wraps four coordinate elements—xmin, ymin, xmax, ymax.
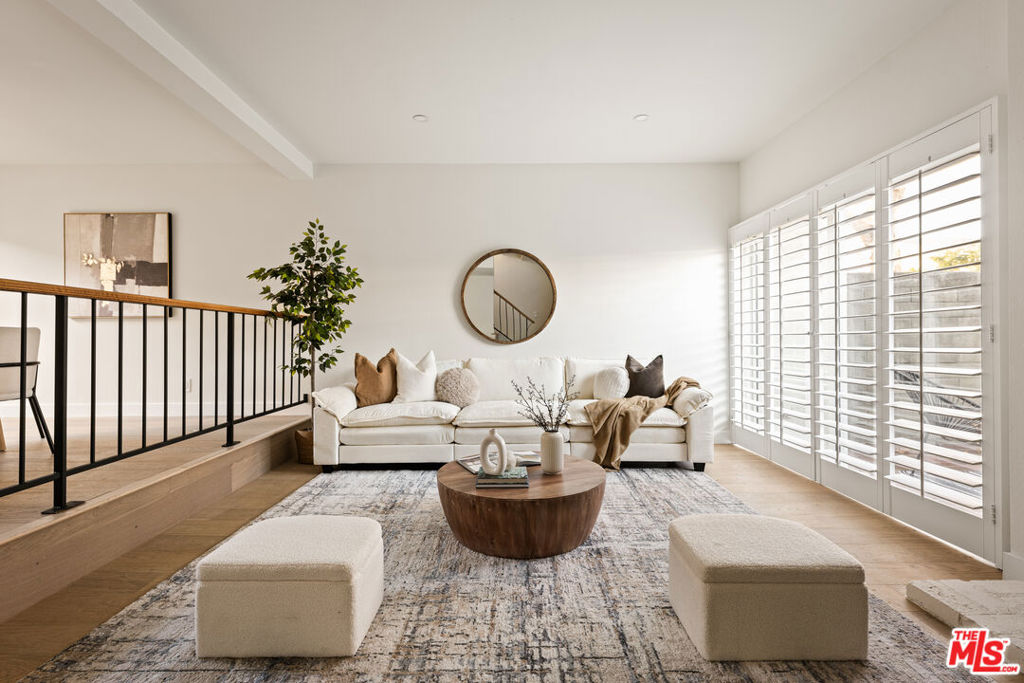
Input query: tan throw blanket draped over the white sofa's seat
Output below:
<box><xmin>583</xmin><ymin>377</ymin><xmax>700</xmax><ymax>470</ymax></box>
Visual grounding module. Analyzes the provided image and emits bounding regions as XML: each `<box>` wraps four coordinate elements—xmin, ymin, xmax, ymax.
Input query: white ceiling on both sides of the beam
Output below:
<box><xmin>6</xmin><ymin>0</ymin><xmax>952</xmax><ymax>164</ymax></box>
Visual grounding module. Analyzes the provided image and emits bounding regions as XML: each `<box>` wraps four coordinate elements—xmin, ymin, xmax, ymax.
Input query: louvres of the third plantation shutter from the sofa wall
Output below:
<box><xmin>815</xmin><ymin>187</ymin><xmax>878</xmax><ymax>477</ymax></box>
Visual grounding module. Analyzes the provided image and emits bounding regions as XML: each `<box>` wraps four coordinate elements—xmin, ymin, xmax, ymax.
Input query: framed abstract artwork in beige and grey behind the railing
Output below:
<box><xmin>65</xmin><ymin>212</ymin><xmax>171</xmax><ymax>317</ymax></box>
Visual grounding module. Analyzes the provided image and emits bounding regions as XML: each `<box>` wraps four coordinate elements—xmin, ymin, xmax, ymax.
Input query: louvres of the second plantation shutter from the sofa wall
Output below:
<box><xmin>767</xmin><ymin>200</ymin><xmax>813</xmax><ymax>452</ymax></box>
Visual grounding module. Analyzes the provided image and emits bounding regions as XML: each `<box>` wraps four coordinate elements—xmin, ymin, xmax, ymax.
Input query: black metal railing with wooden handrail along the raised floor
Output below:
<box><xmin>0</xmin><ymin>279</ymin><xmax>307</xmax><ymax>514</ymax></box>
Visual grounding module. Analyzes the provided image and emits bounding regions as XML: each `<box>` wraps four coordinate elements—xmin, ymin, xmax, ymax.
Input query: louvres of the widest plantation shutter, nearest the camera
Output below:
<box><xmin>887</xmin><ymin>144</ymin><xmax>983</xmax><ymax>516</ymax></box>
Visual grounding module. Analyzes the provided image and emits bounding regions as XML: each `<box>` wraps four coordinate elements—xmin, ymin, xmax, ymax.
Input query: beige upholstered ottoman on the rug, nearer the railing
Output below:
<box><xmin>196</xmin><ymin>515</ymin><xmax>384</xmax><ymax>657</ymax></box>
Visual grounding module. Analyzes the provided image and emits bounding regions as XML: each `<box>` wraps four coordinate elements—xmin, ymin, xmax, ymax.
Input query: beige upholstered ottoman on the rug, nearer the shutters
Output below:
<box><xmin>669</xmin><ymin>515</ymin><xmax>867</xmax><ymax>660</ymax></box>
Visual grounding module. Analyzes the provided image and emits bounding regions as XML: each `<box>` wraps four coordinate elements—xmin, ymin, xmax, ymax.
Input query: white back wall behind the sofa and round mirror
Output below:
<box><xmin>0</xmin><ymin>160</ymin><xmax>737</xmax><ymax>439</ymax></box>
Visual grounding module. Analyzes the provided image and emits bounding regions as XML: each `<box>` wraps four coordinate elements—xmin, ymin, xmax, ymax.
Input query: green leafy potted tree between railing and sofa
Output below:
<box><xmin>249</xmin><ymin>218</ymin><xmax>362</xmax><ymax>465</ymax></box>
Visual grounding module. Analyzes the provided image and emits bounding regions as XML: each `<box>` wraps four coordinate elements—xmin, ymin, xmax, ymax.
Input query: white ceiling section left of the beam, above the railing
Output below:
<box><xmin>0</xmin><ymin>0</ymin><xmax>255</xmax><ymax>164</ymax></box>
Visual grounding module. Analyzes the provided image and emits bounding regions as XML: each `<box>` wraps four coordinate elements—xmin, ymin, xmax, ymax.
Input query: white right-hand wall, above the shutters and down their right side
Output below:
<box><xmin>739</xmin><ymin>0</ymin><xmax>1024</xmax><ymax>579</ymax></box>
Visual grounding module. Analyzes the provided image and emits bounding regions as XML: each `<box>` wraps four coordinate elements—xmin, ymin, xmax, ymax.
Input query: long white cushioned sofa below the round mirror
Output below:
<box><xmin>313</xmin><ymin>357</ymin><xmax>714</xmax><ymax>470</ymax></box>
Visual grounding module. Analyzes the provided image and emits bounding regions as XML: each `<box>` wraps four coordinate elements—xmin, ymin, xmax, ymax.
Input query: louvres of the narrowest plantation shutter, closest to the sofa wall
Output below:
<box><xmin>730</xmin><ymin>233</ymin><xmax>765</xmax><ymax>434</ymax></box>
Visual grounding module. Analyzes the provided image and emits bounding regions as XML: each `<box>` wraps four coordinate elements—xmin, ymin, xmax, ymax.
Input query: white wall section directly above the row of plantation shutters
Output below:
<box><xmin>739</xmin><ymin>0</ymin><xmax>1007</xmax><ymax>217</ymax></box>
